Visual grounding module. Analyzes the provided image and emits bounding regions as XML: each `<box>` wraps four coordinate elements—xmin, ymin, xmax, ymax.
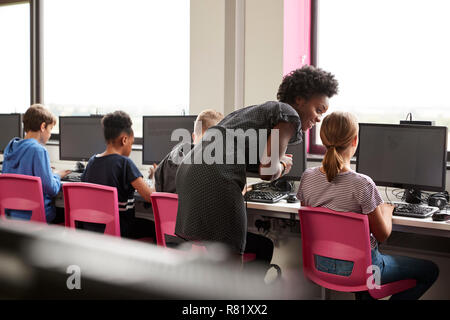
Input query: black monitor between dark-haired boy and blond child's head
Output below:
<box><xmin>142</xmin><ymin>116</ymin><xmax>197</xmax><ymax>164</ymax></box>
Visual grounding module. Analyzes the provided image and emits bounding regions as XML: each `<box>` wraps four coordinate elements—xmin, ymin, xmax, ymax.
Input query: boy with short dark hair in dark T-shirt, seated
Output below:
<box><xmin>80</xmin><ymin>111</ymin><xmax>155</xmax><ymax>239</ymax></box>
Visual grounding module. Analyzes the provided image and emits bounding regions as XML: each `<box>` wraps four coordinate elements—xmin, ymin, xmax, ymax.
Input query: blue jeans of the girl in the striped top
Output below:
<box><xmin>316</xmin><ymin>247</ymin><xmax>439</xmax><ymax>300</ymax></box>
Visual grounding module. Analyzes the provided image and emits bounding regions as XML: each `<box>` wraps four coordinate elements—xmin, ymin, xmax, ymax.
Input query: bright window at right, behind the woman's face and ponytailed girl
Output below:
<box><xmin>311</xmin><ymin>0</ymin><xmax>450</xmax><ymax>154</ymax></box>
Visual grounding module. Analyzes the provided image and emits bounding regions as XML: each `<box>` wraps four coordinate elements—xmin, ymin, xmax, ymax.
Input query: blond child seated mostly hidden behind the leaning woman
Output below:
<box><xmin>155</xmin><ymin>109</ymin><xmax>279</xmax><ymax>278</ymax></box>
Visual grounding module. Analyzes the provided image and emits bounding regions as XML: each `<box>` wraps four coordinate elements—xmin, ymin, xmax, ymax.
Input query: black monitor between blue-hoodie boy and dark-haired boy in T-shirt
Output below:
<box><xmin>59</xmin><ymin>116</ymin><xmax>106</xmax><ymax>161</ymax></box>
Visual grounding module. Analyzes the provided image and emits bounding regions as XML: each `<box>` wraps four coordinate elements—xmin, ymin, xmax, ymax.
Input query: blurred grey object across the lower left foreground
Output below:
<box><xmin>0</xmin><ymin>221</ymin><xmax>308</xmax><ymax>300</ymax></box>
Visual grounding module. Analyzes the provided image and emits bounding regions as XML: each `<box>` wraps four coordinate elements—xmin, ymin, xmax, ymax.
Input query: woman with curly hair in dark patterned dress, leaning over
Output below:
<box><xmin>176</xmin><ymin>66</ymin><xmax>338</xmax><ymax>270</ymax></box>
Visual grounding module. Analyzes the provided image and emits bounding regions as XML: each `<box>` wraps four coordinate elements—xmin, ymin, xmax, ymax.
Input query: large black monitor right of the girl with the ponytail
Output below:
<box><xmin>356</xmin><ymin>123</ymin><xmax>447</xmax><ymax>191</ymax></box>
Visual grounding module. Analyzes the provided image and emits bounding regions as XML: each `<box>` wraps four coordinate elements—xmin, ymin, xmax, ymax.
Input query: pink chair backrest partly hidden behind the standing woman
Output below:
<box><xmin>151</xmin><ymin>192</ymin><xmax>178</xmax><ymax>247</ymax></box>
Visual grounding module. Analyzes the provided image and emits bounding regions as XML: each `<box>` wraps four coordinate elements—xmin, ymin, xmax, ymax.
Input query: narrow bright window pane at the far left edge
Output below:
<box><xmin>0</xmin><ymin>2</ymin><xmax>30</xmax><ymax>113</ymax></box>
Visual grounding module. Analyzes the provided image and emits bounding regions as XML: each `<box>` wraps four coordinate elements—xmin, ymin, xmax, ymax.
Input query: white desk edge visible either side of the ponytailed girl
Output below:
<box><xmin>247</xmin><ymin>200</ymin><xmax>450</xmax><ymax>238</ymax></box>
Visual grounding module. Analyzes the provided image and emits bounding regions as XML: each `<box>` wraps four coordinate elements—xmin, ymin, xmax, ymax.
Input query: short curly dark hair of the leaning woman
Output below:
<box><xmin>277</xmin><ymin>65</ymin><xmax>339</xmax><ymax>105</ymax></box>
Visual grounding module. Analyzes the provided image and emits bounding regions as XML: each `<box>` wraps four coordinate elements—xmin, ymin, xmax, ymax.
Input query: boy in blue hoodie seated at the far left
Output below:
<box><xmin>2</xmin><ymin>104</ymin><xmax>70</xmax><ymax>223</ymax></box>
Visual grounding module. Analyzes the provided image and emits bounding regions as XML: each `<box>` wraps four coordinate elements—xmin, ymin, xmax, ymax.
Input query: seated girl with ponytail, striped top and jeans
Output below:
<box><xmin>297</xmin><ymin>112</ymin><xmax>439</xmax><ymax>300</ymax></box>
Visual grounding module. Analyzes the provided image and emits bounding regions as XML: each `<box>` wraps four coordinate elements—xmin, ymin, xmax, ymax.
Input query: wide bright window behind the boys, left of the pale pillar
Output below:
<box><xmin>43</xmin><ymin>0</ymin><xmax>190</xmax><ymax>137</ymax></box>
